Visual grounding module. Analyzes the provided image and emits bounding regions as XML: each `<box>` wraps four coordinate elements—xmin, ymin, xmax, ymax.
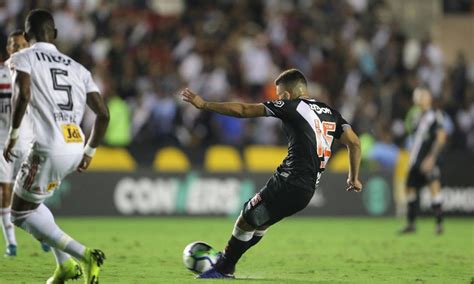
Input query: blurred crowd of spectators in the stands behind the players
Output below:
<box><xmin>0</xmin><ymin>0</ymin><xmax>474</xmax><ymax>167</ymax></box>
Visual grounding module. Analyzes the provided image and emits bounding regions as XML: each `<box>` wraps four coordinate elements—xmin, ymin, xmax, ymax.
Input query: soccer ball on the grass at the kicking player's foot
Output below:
<box><xmin>183</xmin><ymin>241</ymin><xmax>221</xmax><ymax>274</ymax></box>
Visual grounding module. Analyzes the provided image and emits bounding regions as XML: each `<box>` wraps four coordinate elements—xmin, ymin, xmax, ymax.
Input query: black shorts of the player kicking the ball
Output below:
<box><xmin>242</xmin><ymin>174</ymin><xmax>314</xmax><ymax>228</ymax></box>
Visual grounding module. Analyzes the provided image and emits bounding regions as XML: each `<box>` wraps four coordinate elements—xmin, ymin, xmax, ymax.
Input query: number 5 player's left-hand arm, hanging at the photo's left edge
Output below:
<box><xmin>3</xmin><ymin>71</ymin><xmax>31</xmax><ymax>162</ymax></box>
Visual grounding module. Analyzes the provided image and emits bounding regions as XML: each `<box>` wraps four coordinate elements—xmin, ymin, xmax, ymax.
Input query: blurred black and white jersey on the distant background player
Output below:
<box><xmin>410</xmin><ymin>109</ymin><xmax>444</xmax><ymax>168</ymax></box>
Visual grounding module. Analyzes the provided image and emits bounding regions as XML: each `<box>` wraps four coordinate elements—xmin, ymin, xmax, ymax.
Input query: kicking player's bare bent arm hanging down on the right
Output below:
<box><xmin>340</xmin><ymin>128</ymin><xmax>362</xmax><ymax>192</ymax></box>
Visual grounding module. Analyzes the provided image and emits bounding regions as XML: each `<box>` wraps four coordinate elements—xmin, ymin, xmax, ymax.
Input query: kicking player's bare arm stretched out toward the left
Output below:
<box><xmin>181</xmin><ymin>89</ymin><xmax>265</xmax><ymax>118</ymax></box>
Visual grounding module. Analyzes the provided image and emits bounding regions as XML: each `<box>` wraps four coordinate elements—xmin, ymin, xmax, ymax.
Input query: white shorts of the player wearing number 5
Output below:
<box><xmin>13</xmin><ymin>150</ymin><xmax>83</xmax><ymax>203</ymax></box>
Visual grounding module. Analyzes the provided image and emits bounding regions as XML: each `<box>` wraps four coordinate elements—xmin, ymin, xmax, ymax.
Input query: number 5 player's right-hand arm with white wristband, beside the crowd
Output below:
<box><xmin>77</xmin><ymin>92</ymin><xmax>110</xmax><ymax>172</ymax></box>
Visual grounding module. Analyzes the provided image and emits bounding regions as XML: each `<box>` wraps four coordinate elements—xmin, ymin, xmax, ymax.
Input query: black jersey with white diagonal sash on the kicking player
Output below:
<box><xmin>264</xmin><ymin>99</ymin><xmax>350</xmax><ymax>190</ymax></box>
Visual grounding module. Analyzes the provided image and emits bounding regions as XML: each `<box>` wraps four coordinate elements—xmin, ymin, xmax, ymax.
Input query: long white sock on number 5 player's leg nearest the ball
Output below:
<box><xmin>12</xmin><ymin>204</ymin><xmax>85</xmax><ymax>264</ymax></box>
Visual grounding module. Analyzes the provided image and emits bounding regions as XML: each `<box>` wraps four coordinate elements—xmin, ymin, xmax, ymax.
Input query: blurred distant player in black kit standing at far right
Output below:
<box><xmin>400</xmin><ymin>87</ymin><xmax>447</xmax><ymax>235</ymax></box>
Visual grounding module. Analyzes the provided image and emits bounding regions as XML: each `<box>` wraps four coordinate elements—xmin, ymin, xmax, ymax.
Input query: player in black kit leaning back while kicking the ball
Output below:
<box><xmin>181</xmin><ymin>69</ymin><xmax>362</xmax><ymax>278</ymax></box>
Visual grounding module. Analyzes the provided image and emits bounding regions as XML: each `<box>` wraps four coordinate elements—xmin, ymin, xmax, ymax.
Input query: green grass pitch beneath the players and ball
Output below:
<box><xmin>0</xmin><ymin>218</ymin><xmax>474</xmax><ymax>283</ymax></box>
